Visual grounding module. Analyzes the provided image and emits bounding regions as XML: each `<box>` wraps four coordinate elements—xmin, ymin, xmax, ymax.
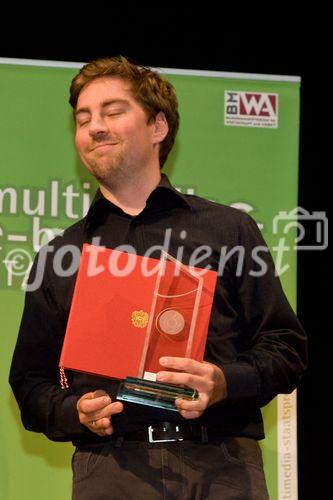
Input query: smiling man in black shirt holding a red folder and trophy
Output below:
<box><xmin>10</xmin><ymin>57</ymin><xmax>307</xmax><ymax>500</ymax></box>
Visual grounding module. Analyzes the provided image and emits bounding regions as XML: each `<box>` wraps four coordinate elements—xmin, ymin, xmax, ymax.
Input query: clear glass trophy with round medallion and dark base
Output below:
<box><xmin>117</xmin><ymin>251</ymin><xmax>203</xmax><ymax>411</ymax></box>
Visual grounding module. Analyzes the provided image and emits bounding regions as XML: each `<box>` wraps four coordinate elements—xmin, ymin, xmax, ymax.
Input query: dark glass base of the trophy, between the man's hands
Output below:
<box><xmin>117</xmin><ymin>377</ymin><xmax>199</xmax><ymax>411</ymax></box>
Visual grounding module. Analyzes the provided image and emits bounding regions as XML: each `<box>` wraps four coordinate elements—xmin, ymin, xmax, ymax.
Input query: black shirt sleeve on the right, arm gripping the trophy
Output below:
<box><xmin>221</xmin><ymin>214</ymin><xmax>307</xmax><ymax>407</ymax></box>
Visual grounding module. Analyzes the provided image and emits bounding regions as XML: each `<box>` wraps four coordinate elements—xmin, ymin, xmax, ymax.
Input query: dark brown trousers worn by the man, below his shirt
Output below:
<box><xmin>72</xmin><ymin>437</ymin><xmax>269</xmax><ymax>500</ymax></box>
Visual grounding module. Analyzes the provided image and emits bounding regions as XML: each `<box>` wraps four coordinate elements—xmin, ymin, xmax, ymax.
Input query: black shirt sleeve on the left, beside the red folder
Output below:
<box><xmin>9</xmin><ymin>247</ymin><xmax>93</xmax><ymax>441</ymax></box>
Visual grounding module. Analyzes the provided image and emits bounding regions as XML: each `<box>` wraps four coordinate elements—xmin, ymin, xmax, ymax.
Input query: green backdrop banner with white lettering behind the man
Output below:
<box><xmin>0</xmin><ymin>60</ymin><xmax>300</xmax><ymax>500</ymax></box>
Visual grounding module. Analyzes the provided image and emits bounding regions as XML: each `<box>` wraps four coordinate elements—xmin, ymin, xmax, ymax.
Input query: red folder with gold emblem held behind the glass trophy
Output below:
<box><xmin>59</xmin><ymin>244</ymin><xmax>217</xmax><ymax>379</ymax></box>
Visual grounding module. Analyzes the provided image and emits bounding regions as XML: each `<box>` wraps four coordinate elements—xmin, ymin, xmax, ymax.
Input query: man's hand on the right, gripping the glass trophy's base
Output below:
<box><xmin>157</xmin><ymin>356</ymin><xmax>227</xmax><ymax>419</ymax></box>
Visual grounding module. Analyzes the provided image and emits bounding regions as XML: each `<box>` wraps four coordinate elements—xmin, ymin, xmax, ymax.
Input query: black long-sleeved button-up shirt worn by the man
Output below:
<box><xmin>9</xmin><ymin>175</ymin><xmax>307</xmax><ymax>445</ymax></box>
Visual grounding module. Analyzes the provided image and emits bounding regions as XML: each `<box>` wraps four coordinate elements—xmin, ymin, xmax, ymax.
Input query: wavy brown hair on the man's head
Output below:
<box><xmin>69</xmin><ymin>56</ymin><xmax>179</xmax><ymax>168</ymax></box>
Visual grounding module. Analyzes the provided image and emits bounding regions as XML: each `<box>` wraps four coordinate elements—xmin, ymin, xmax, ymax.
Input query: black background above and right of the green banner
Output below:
<box><xmin>0</xmin><ymin>9</ymin><xmax>326</xmax><ymax>500</ymax></box>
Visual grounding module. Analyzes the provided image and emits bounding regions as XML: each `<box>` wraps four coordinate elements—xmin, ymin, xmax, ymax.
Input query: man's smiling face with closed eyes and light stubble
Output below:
<box><xmin>75</xmin><ymin>77</ymin><xmax>160</xmax><ymax>186</ymax></box>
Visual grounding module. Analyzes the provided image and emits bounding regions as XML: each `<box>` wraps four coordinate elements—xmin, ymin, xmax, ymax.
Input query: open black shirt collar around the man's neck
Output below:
<box><xmin>85</xmin><ymin>173</ymin><xmax>193</xmax><ymax>226</ymax></box>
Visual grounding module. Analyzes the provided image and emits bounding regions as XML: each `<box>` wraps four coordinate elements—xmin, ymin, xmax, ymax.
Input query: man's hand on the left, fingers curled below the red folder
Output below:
<box><xmin>76</xmin><ymin>389</ymin><xmax>124</xmax><ymax>436</ymax></box>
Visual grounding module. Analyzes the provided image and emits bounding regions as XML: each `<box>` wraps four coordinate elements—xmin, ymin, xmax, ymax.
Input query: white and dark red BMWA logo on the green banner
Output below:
<box><xmin>224</xmin><ymin>90</ymin><xmax>278</xmax><ymax>128</ymax></box>
